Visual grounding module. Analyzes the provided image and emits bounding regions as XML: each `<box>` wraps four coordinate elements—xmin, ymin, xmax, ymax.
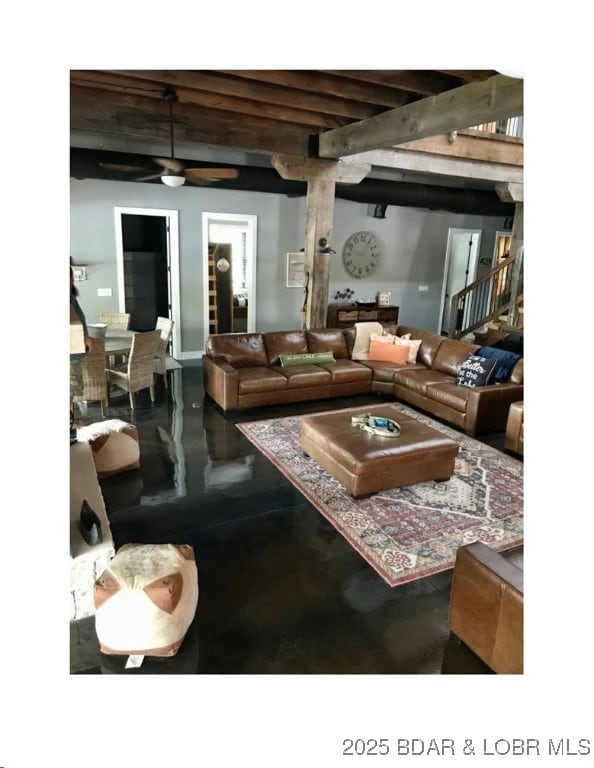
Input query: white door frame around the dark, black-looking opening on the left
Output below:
<box><xmin>113</xmin><ymin>206</ymin><xmax>181</xmax><ymax>359</ymax></box>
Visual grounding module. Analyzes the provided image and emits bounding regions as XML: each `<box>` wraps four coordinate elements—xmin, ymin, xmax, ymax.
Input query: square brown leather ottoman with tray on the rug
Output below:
<box><xmin>301</xmin><ymin>404</ymin><xmax>459</xmax><ymax>499</ymax></box>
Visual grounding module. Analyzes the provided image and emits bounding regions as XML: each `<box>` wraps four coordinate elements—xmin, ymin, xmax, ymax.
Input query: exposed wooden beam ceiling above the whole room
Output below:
<box><xmin>70</xmin><ymin>70</ymin><xmax>523</xmax><ymax>212</ymax></box>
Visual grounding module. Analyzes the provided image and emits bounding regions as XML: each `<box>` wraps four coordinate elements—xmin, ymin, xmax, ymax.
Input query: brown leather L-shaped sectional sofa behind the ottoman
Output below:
<box><xmin>202</xmin><ymin>325</ymin><xmax>523</xmax><ymax>435</ymax></box>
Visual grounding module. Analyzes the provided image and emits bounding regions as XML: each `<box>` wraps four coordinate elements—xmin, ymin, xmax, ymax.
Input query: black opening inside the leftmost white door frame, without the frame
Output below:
<box><xmin>122</xmin><ymin>213</ymin><xmax>170</xmax><ymax>331</ymax></box>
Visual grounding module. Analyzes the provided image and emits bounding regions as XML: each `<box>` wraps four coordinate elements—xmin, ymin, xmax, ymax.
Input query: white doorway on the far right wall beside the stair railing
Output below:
<box><xmin>440</xmin><ymin>228</ymin><xmax>482</xmax><ymax>336</ymax></box>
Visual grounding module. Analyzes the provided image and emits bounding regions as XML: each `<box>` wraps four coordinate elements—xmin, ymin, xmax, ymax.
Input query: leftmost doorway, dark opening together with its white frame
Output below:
<box><xmin>114</xmin><ymin>208</ymin><xmax>181</xmax><ymax>357</ymax></box>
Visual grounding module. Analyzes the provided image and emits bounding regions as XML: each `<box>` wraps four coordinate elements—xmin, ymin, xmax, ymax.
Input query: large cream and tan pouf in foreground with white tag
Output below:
<box><xmin>94</xmin><ymin>544</ymin><xmax>198</xmax><ymax>656</ymax></box>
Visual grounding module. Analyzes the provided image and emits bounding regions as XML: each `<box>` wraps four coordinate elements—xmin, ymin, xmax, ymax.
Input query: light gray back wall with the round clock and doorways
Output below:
<box><xmin>70</xmin><ymin>179</ymin><xmax>504</xmax><ymax>358</ymax></box>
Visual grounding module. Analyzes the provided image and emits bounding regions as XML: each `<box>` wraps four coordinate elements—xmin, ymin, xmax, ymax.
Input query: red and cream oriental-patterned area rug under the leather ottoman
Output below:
<box><xmin>236</xmin><ymin>403</ymin><xmax>524</xmax><ymax>587</ymax></box>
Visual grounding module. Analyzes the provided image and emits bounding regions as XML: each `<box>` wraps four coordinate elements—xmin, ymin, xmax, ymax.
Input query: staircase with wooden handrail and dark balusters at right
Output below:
<box><xmin>447</xmin><ymin>248</ymin><xmax>524</xmax><ymax>339</ymax></box>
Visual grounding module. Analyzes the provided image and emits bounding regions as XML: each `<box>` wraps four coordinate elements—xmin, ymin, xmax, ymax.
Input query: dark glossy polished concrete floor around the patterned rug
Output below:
<box><xmin>70</xmin><ymin>363</ymin><xmax>503</xmax><ymax>675</ymax></box>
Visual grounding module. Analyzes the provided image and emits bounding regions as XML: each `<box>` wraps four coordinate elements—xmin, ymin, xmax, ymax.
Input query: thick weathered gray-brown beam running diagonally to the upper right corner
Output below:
<box><xmin>319</xmin><ymin>75</ymin><xmax>524</xmax><ymax>158</ymax></box>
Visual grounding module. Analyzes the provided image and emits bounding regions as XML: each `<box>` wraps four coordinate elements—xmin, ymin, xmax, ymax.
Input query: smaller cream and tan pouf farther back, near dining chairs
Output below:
<box><xmin>77</xmin><ymin>419</ymin><xmax>140</xmax><ymax>479</ymax></box>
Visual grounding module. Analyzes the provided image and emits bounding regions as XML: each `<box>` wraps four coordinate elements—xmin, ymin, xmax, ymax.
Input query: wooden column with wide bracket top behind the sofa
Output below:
<box><xmin>271</xmin><ymin>155</ymin><xmax>371</xmax><ymax>328</ymax></box>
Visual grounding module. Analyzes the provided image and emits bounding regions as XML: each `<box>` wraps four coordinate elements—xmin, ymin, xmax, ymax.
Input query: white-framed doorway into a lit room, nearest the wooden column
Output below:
<box><xmin>202</xmin><ymin>212</ymin><xmax>258</xmax><ymax>338</ymax></box>
